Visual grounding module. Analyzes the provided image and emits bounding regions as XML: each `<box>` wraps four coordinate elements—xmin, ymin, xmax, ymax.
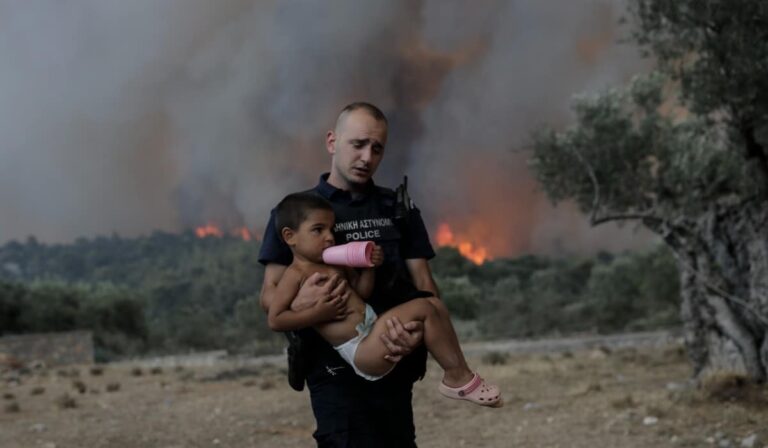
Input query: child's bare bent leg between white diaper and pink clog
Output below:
<box><xmin>355</xmin><ymin>299</ymin><xmax>473</xmax><ymax>387</ymax></box>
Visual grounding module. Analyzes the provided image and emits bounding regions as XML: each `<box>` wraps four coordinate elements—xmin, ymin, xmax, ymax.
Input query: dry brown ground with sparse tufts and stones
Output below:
<box><xmin>0</xmin><ymin>345</ymin><xmax>768</xmax><ymax>448</ymax></box>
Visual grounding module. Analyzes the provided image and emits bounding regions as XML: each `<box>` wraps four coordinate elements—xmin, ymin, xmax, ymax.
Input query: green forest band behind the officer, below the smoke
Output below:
<box><xmin>0</xmin><ymin>232</ymin><xmax>679</xmax><ymax>361</ymax></box>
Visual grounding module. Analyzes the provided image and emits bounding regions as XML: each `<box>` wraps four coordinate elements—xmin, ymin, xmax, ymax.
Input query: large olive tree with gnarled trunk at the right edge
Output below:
<box><xmin>532</xmin><ymin>0</ymin><xmax>768</xmax><ymax>381</ymax></box>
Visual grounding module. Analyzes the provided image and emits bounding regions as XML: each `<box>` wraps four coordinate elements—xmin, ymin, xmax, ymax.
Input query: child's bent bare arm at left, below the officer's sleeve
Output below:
<box><xmin>267</xmin><ymin>268</ymin><xmax>346</xmax><ymax>331</ymax></box>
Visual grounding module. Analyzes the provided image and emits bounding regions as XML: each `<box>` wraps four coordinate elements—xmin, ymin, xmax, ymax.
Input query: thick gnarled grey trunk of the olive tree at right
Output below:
<box><xmin>672</xmin><ymin>202</ymin><xmax>768</xmax><ymax>382</ymax></box>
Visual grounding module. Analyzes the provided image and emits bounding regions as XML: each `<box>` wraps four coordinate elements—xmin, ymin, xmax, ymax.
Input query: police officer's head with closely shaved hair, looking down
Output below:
<box><xmin>326</xmin><ymin>110</ymin><xmax>387</xmax><ymax>190</ymax></box>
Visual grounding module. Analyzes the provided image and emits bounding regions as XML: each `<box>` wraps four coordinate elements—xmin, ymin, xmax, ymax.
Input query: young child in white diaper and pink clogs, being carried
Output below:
<box><xmin>268</xmin><ymin>193</ymin><xmax>503</xmax><ymax>407</ymax></box>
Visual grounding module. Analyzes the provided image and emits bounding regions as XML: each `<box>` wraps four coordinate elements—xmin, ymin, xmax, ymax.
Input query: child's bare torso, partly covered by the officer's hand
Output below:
<box><xmin>289</xmin><ymin>263</ymin><xmax>365</xmax><ymax>346</ymax></box>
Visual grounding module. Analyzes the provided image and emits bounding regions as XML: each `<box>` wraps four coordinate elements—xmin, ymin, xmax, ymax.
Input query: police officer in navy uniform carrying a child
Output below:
<box><xmin>259</xmin><ymin>103</ymin><xmax>437</xmax><ymax>448</ymax></box>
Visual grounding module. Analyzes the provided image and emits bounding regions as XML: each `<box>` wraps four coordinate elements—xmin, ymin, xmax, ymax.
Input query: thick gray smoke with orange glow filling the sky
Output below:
<box><xmin>0</xmin><ymin>0</ymin><xmax>656</xmax><ymax>255</ymax></box>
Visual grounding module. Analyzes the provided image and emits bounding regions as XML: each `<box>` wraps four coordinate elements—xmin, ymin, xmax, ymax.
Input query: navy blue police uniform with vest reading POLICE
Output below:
<box><xmin>259</xmin><ymin>173</ymin><xmax>435</xmax><ymax>448</ymax></box>
